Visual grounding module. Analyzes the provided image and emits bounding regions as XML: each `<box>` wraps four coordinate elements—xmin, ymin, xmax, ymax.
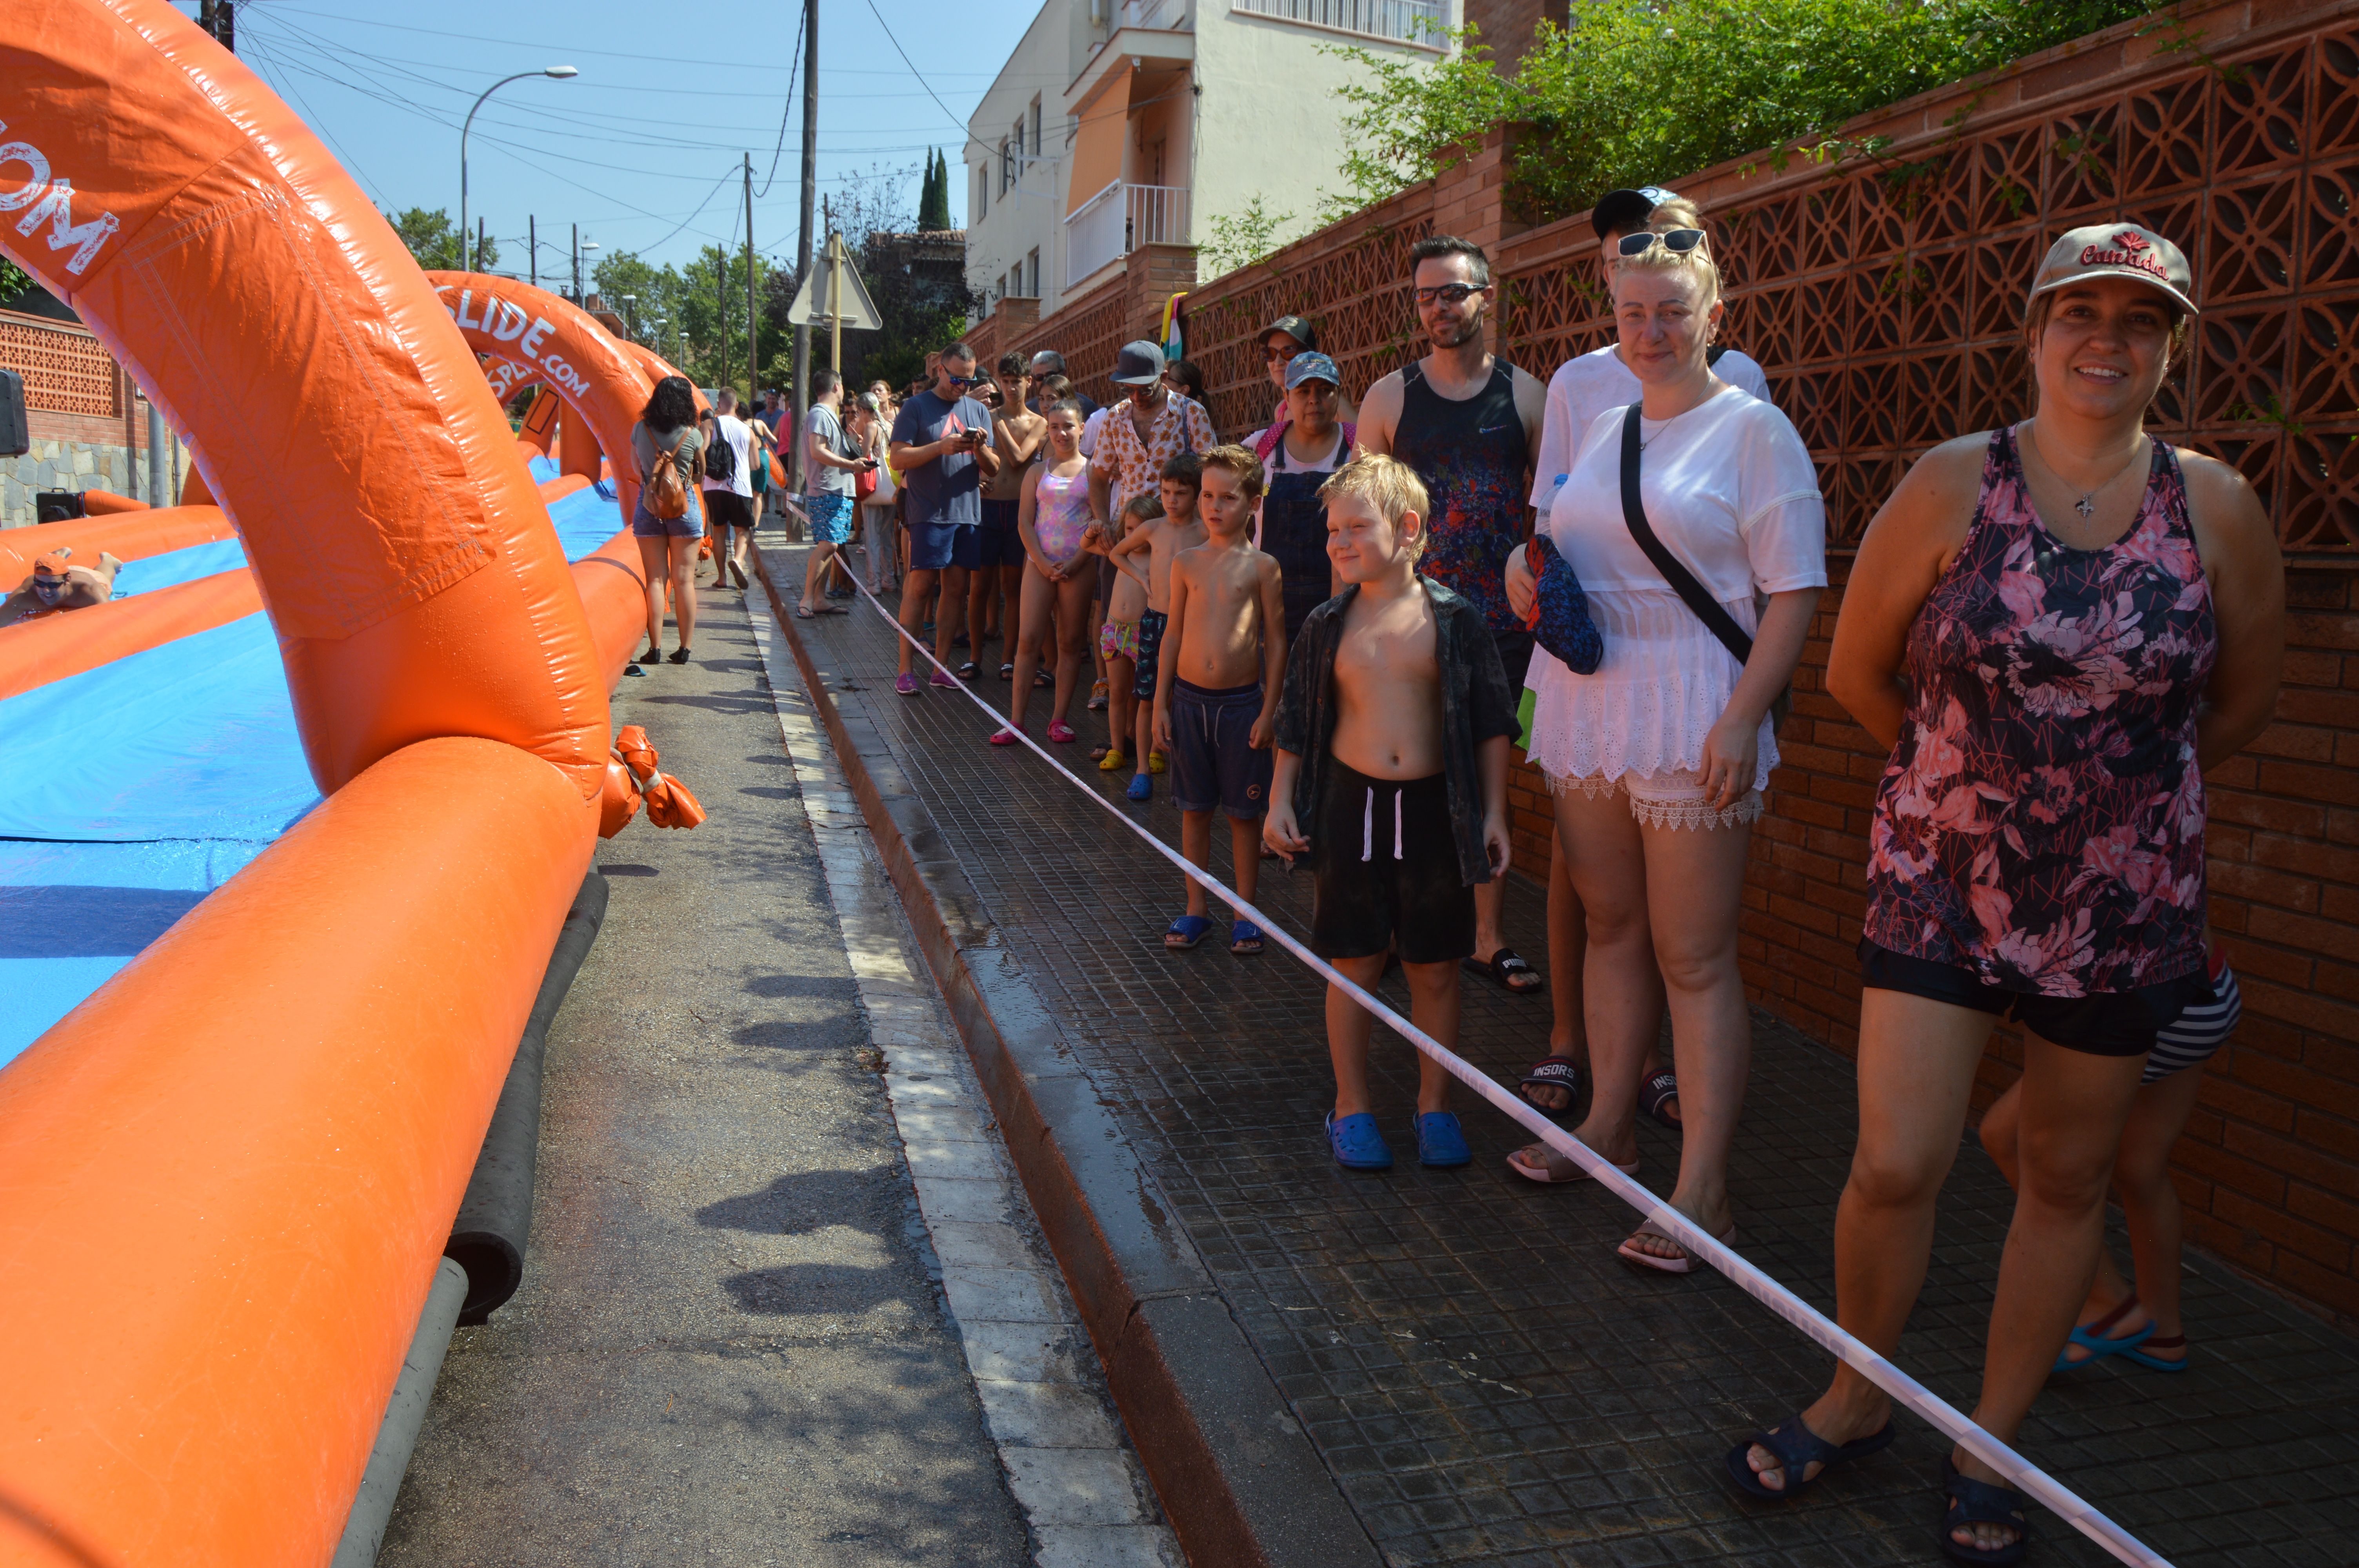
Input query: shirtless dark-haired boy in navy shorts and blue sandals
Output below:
<box><xmin>1140</xmin><ymin>446</ymin><xmax>1286</xmax><ymax>955</ymax></box>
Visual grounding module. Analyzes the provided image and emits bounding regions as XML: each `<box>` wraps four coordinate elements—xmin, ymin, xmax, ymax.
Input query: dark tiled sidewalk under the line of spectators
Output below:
<box><xmin>790</xmin><ymin>557</ymin><xmax>2359</xmax><ymax>1568</ymax></box>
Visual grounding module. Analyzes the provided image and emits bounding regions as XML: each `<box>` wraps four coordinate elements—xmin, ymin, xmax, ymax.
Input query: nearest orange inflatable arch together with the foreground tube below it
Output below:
<box><xmin>0</xmin><ymin>0</ymin><xmax>609</xmax><ymax>1568</ymax></box>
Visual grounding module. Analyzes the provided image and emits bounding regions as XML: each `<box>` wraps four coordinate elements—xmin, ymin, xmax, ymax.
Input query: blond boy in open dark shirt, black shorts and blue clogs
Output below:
<box><xmin>1262</xmin><ymin>455</ymin><xmax>1514</xmax><ymax>1169</ymax></box>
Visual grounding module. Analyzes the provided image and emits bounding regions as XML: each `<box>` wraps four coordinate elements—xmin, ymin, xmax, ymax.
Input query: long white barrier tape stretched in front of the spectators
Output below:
<box><xmin>811</xmin><ymin>566</ymin><xmax>2170</xmax><ymax>1568</ymax></box>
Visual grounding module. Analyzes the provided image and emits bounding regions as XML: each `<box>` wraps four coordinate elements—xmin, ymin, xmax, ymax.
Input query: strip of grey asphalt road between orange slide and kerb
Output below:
<box><xmin>378</xmin><ymin>575</ymin><xmax>1029</xmax><ymax>1568</ymax></box>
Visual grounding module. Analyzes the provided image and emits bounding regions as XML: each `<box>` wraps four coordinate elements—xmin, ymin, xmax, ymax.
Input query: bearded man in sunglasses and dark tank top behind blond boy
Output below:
<box><xmin>1359</xmin><ymin>233</ymin><xmax>1547</xmax><ymax>995</ymax></box>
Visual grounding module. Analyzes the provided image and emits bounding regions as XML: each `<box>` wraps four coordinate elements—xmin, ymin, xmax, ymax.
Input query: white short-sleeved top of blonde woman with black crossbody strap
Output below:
<box><xmin>1531</xmin><ymin>382</ymin><xmax>1826</xmax><ymax>790</ymax></box>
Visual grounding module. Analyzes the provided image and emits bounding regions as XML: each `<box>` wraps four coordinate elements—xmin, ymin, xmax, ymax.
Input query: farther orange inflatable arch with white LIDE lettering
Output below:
<box><xmin>427</xmin><ymin>271</ymin><xmax>653</xmax><ymax>526</ymax></box>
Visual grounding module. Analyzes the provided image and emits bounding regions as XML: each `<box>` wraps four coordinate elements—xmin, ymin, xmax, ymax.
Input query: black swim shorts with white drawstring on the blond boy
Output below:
<box><xmin>1309</xmin><ymin>759</ymin><xmax>1474</xmax><ymax>964</ymax></box>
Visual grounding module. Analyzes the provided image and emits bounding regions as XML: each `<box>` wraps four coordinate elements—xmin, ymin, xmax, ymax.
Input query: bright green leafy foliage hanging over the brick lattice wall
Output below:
<box><xmin>1321</xmin><ymin>0</ymin><xmax>2149</xmax><ymax>221</ymax></box>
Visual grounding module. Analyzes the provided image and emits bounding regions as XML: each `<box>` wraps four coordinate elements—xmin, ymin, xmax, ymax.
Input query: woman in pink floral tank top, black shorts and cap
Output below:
<box><xmin>1727</xmin><ymin>224</ymin><xmax>2283</xmax><ymax>1563</ymax></box>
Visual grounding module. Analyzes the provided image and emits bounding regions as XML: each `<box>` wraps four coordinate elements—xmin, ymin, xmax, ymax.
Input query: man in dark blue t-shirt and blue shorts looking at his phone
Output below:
<box><xmin>892</xmin><ymin>342</ymin><xmax>1000</xmax><ymax>698</ymax></box>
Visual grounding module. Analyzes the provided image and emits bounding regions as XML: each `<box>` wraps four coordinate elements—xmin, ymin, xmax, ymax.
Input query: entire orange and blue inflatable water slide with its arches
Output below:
<box><xmin>0</xmin><ymin>0</ymin><xmax>698</xmax><ymax>1568</ymax></box>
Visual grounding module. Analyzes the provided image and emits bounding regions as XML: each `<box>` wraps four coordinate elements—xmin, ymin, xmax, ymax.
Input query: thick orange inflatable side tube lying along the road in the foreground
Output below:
<box><xmin>0</xmin><ymin>740</ymin><xmax>587</xmax><ymax>1568</ymax></box>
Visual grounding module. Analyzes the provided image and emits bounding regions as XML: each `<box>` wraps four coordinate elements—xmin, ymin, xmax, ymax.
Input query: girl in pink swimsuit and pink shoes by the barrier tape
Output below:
<box><xmin>991</xmin><ymin>399</ymin><xmax>1097</xmax><ymax>745</ymax></box>
